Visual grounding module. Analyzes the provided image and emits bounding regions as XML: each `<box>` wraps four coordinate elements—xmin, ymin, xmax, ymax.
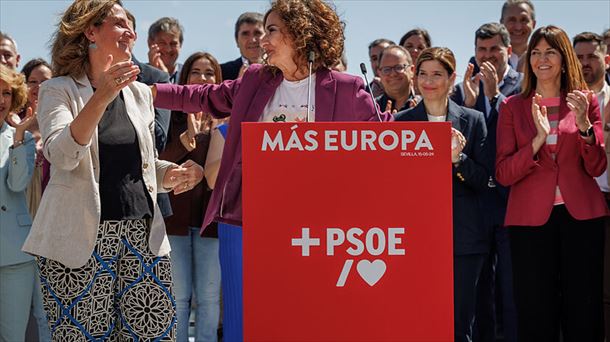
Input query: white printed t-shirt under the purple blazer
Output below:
<box><xmin>260</xmin><ymin>74</ymin><xmax>316</xmax><ymax>122</ymax></box>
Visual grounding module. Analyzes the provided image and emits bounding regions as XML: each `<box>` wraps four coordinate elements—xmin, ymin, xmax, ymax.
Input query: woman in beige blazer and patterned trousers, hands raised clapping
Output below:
<box><xmin>23</xmin><ymin>0</ymin><xmax>202</xmax><ymax>341</ymax></box>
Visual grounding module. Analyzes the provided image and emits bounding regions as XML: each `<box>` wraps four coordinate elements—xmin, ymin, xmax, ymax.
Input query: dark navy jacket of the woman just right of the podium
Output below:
<box><xmin>395</xmin><ymin>100</ymin><xmax>490</xmax><ymax>255</ymax></box>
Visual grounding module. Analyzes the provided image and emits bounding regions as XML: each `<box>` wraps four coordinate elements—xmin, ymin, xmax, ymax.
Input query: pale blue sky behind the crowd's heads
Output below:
<box><xmin>0</xmin><ymin>0</ymin><xmax>610</xmax><ymax>80</ymax></box>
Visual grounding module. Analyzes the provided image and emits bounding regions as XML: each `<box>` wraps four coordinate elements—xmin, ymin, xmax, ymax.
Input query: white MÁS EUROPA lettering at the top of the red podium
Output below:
<box><xmin>261</xmin><ymin>125</ymin><xmax>434</xmax><ymax>152</ymax></box>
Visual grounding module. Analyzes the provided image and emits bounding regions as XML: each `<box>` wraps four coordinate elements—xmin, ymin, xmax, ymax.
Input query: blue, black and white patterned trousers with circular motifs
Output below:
<box><xmin>37</xmin><ymin>219</ymin><xmax>176</xmax><ymax>341</ymax></box>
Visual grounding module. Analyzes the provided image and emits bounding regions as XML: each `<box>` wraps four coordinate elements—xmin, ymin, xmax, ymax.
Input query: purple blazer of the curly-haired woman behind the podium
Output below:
<box><xmin>154</xmin><ymin>64</ymin><xmax>392</xmax><ymax>229</ymax></box>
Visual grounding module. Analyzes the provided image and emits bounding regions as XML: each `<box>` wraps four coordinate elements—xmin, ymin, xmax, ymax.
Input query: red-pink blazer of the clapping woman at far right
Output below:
<box><xmin>496</xmin><ymin>93</ymin><xmax>609</xmax><ymax>226</ymax></box>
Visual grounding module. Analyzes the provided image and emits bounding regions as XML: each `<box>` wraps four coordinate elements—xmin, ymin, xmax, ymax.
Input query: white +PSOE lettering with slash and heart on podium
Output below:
<box><xmin>291</xmin><ymin>227</ymin><xmax>405</xmax><ymax>287</ymax></box>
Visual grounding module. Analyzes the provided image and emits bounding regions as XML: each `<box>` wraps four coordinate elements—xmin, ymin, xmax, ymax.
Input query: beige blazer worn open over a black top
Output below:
<box><xmin>23</xmin><ymin>75</ymin><xmax>175</xmax><ymax>268</ymax></box>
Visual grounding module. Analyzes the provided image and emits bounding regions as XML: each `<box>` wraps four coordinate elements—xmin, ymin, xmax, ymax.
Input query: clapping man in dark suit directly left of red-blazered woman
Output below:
<box><xmin>452</xmin><ymin>23</ymin><xmax>523</xmax><ymax>342</ymax></box>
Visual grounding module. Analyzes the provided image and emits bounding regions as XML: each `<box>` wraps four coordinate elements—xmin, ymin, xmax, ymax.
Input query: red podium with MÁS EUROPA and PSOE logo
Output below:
<box><xmin>242</xmin><ymin>122</ymin><xmax>453</xmax><ymax>341</ymax></box>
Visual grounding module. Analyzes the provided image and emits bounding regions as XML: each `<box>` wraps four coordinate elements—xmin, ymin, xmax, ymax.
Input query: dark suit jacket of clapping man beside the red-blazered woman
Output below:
<box><xmin>451</xmin><ymin>66</ymin><xmax>523</xmax><ymax>227</ymax></box>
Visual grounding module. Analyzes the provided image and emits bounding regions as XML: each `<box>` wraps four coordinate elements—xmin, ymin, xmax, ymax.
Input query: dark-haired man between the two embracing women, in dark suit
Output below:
<box><xmin>220</xmin><ymin>12</ymin><xmax>264</xmax><ymax>81</ymax></box>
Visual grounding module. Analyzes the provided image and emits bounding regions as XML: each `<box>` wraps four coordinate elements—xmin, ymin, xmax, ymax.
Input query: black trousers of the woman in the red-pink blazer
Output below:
<box><xmin>509</xmin><ymin>205</ymin><xmax>604</xmax><ymax>342</ymax></box>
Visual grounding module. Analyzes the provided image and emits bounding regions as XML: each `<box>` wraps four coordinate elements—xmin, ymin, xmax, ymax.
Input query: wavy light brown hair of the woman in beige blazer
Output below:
<box><xmin>51</xmin><ymin>0</ymin><xmax>123</xmax><ymax>77</ymax></box>
